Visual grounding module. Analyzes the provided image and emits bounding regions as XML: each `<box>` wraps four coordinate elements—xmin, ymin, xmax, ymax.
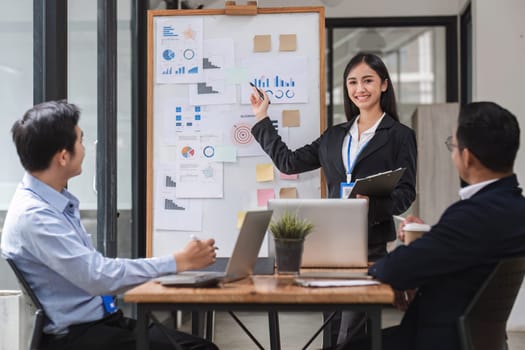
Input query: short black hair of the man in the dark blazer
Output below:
<box><xmin>456</xmin><ymin>102</ymin><xmax>520</xmax><ymax>172</ymax></box>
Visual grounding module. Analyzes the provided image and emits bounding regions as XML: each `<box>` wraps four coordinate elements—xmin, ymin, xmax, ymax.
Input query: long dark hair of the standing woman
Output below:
<box><xmin>343</xmin><ymin>52</ymin><xmax>399</xmax><ymax>121</ymax></box>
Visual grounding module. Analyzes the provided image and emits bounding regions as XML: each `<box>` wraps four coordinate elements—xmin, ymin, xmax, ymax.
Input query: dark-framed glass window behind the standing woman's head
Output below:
<box><xmin>328</xmin><ymin>27</ymin><xmax>446</xmax><ymax>126</ymax></box>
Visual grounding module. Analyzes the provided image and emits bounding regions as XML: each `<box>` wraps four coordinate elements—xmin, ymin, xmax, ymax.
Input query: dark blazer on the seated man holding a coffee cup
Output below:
<box><xmin>369</xmin><ymin>175</ymin><xmax>525</xmax><ymax>350</ymax></box>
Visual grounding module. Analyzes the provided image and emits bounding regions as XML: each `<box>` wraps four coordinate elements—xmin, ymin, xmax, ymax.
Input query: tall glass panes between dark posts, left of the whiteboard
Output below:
<box><xmin>68</xmin><ymin>0</ymin><xmax>131</xmax><ymax>257</ymax></box>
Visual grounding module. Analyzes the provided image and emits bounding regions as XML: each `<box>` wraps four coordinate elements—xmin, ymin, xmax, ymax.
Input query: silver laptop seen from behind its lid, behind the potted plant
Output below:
<box><xmin>268</xmin><ymin>198</ymin><xmax>368</xmax><ymax>268</ymax></box>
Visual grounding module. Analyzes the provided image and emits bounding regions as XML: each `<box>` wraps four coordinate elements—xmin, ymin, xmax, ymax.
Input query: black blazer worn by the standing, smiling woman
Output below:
<box><xmin>252</xmin><ymin>115</ymin><xmax>417</xmax><ymax>246</ymax></box>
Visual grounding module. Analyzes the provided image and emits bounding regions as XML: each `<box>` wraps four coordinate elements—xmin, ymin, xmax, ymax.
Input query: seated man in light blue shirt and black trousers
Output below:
<box><xmin>1</xmin><ymin>101</ymin><xmax>216</xmax><ymax>350</ymax></box>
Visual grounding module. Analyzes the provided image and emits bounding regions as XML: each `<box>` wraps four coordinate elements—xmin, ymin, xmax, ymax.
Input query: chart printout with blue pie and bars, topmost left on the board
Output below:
<box><xmin>155</xmin><ymin>17</ymin><xmax>203</xmax><ymax>84</ymax></box>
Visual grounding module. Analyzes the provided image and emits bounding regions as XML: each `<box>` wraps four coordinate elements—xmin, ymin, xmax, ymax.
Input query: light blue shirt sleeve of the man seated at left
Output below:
<box><xmin>19</xmin><ymin>208</ymin><xmax>176</xmax><ymax>295</ymax></box>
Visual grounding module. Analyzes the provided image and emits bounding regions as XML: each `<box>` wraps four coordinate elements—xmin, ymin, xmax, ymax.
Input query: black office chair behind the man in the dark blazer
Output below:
<box><xmin>458</xmin><ymin>257</ymin><xmax>525</xmax><ymax>350</ymax></box>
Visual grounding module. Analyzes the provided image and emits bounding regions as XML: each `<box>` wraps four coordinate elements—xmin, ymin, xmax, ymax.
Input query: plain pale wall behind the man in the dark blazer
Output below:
<box><xmin>472</xmin><ymin>0</ymin><xmax>525</xmax><ymax>331</ymax></box>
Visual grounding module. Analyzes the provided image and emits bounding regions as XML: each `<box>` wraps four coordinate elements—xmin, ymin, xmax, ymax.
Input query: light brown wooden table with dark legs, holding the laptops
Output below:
<box><xmin>124</xmin><ymin>275</ymin><xmax>394</xmax><ymax>350</ymax></box>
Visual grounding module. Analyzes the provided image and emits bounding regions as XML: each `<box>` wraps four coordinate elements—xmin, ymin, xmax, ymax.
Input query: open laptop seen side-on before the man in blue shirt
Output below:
<box><xmin>154</xmin><ymin>210</ymin><xmax>272</xmax><ymax>287</ymax></box>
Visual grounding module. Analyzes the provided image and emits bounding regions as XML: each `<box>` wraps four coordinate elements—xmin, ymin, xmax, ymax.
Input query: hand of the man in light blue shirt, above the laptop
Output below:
<box><xmin>174</xmin><ymin>238</ymin><xmax>217</xmax><ymax>272</ymax></box>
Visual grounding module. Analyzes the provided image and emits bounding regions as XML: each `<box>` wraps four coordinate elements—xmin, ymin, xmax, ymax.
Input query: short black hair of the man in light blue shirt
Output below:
<box><xmin>11</xmin><ymin>100</ymin><xmax>80</xmax><ymax>171</ymax></box>
